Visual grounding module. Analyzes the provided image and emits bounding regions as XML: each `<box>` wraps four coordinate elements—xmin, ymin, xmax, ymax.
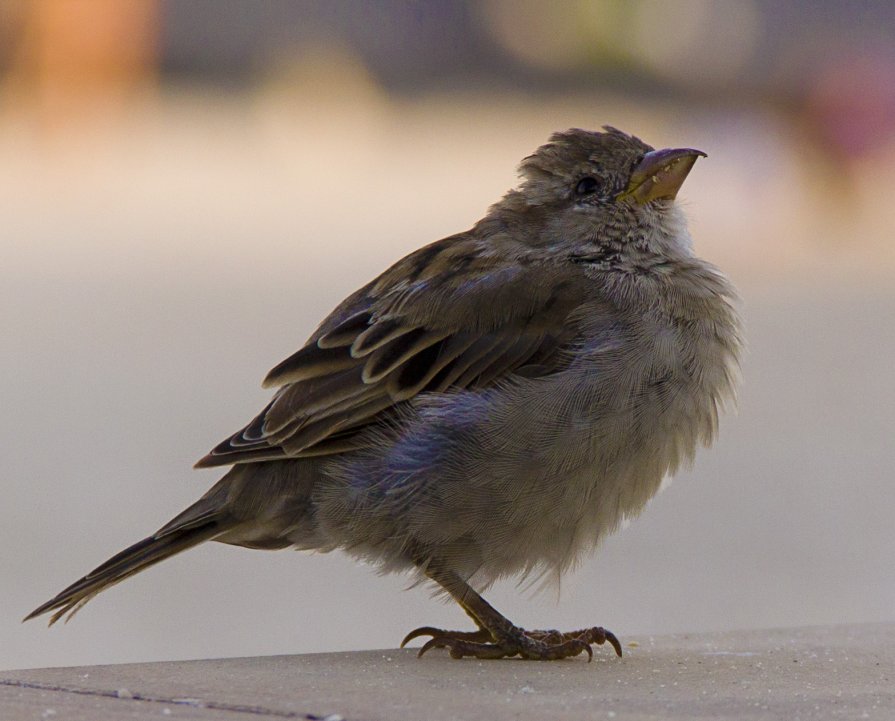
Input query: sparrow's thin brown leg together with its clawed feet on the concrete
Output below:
<box><xmin>401</xmin><ymin>567</ymin><xmax>622</xmax><ymax>661</ymax></box>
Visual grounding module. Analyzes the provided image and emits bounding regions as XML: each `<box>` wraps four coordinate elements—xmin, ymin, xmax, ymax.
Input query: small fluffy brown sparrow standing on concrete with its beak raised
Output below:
<box><xmin>28</xmin><ymin>127</ymin><xmax>741</xmax><ymax>659</ymax></box>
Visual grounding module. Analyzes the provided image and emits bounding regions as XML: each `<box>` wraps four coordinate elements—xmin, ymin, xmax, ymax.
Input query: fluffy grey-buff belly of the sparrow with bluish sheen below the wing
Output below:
<box><xmin>316</xmin><ymin>346</ymin><xmax>720</xmax><ymax>582</ymax></box>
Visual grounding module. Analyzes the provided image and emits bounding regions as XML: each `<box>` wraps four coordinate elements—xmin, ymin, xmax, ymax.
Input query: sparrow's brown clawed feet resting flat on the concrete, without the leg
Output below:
<box><xmin>401</xmin><ymin>626</ymin><xmax>622</xmax><ymax>661</ymax></box>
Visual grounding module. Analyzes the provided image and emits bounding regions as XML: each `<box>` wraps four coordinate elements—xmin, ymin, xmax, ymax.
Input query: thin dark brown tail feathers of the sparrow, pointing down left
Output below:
<box><xmin>23</xmin><ymin>518</ymin><xmax>222</xmax><ymax>626</ymax></box>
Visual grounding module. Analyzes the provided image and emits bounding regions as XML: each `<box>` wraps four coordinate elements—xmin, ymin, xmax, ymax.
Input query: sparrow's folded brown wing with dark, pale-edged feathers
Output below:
<box><xmin>196</xmin><ymin>236</ymin><xmax>584</xmax><ymax>468</ymax></box>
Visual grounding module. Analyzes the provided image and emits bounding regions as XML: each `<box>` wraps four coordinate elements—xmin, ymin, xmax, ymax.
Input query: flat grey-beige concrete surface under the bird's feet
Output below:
<box><xmin>0</xmin><ymin>624</ymin><xmax>895</xmax><ymax>721</ymax></box>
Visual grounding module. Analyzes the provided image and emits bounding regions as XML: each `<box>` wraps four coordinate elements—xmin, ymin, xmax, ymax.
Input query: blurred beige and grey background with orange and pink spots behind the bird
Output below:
<box><xmin>0</xmin><ymin>0</ymin><xmax>895</xmax><ymax>668</ymax></box>
